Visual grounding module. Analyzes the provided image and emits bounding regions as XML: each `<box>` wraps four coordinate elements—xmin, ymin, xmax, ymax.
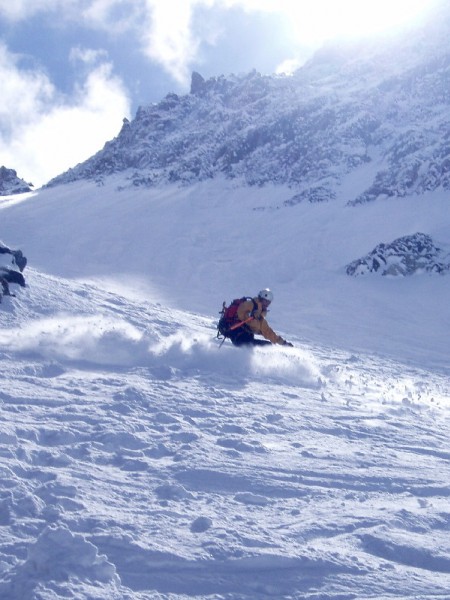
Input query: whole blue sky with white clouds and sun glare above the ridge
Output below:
<box><xmin>0</xmin><ymin>0</ymin><xmax>433</xmax><ymax>188</ymax></box>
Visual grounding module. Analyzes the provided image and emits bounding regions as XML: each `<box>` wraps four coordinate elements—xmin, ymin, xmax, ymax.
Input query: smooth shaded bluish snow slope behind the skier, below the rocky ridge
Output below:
<box><xmin>1</xmin><ymin>176</ymin><xmax>450</xmax><ymax>368</ymax></box>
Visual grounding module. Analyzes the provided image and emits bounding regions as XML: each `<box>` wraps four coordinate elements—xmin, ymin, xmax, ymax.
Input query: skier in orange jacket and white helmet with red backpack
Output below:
<box><xmin>221</xmin><ymin>288</ymin><xmax>292</xmax><ymax>347</ymax></box>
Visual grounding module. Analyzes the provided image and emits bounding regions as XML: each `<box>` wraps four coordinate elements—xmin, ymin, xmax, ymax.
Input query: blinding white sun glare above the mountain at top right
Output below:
<box><xmin>280</xmin><ymin>0</ymin><xmax>433</xmax><ymax>43</ymax></box>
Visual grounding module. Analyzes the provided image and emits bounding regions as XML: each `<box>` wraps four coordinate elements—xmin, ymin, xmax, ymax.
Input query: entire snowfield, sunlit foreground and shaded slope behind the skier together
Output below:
<box><xmin>0</xmin><ymin>179</ymin><xmax>450</xmax><ymax>600</ymax></box>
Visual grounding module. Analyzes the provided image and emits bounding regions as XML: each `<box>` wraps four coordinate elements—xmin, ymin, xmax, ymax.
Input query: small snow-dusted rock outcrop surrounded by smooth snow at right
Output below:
<box><xmin>346</xmin><ymin>233</ymin><xmax>450</xmax><ymax>276</ymax></box>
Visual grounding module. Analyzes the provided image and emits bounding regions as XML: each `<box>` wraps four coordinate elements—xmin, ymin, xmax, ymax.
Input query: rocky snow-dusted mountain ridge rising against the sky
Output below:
<box><xmin>48</xmin><ymin>5</ymin><xmax>450</xmax><ymax>209</ymax></box>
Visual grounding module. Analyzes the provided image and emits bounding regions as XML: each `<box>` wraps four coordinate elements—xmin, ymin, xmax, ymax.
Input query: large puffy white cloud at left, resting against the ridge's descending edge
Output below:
<box><xmin>0</xmin><ymin>47</ymin><xmax>130</xmax><ymax>187</ymax></box>
